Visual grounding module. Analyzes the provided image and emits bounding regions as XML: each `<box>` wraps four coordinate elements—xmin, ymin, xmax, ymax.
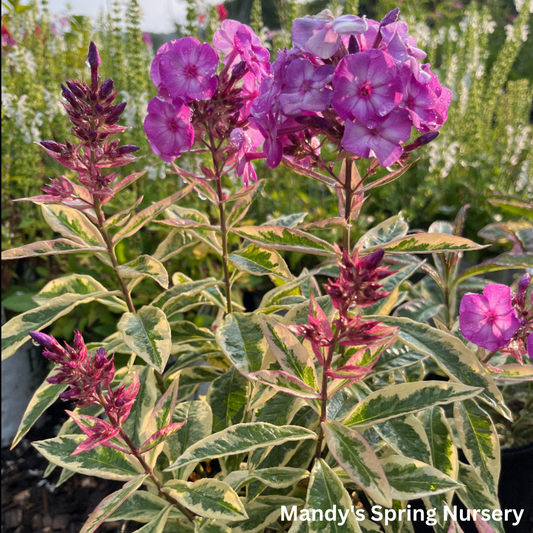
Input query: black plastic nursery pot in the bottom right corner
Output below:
<box><xmin>410</xmin><ymin>442</ymin><xmax>533</xmax><ymax>533</ymax></box>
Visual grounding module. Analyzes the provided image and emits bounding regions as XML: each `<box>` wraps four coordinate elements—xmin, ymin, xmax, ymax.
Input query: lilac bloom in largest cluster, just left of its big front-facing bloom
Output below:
<box><xmin>280</xmin><ymin>58</ymin><xmax>335</xmax><ymax>115</ymax></box>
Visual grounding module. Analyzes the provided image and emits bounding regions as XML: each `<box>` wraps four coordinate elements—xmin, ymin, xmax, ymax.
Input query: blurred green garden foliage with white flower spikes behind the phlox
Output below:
<box><xmin>2</xmin><ymin>0</ymin><xmax>533</xmax><ymax>338</ymax></box>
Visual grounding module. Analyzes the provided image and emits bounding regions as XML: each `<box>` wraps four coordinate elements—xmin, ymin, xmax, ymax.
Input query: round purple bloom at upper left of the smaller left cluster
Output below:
<box><xmin>159</xmin><ymin>37</ymin><xmax>219</xmax><ymax>102</ymax></box>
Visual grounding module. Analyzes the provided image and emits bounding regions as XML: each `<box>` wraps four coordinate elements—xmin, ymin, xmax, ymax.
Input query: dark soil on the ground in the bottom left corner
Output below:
<box><xmin>1</xmin><ymin>402</ymin><xmax>125</xmax><ymax>533</ymax></box>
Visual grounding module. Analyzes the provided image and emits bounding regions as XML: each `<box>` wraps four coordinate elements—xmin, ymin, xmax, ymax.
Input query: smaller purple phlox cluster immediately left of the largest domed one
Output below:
<box><xmin>144</xmin><ymin>20</ymin><xmax>270</xmax><ymax>186</ymax></box>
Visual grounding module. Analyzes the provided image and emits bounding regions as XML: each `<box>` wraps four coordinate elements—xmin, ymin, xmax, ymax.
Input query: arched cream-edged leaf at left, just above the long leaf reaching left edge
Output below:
<box><xmin>33</xmin><ymin>274</ymin><xmax>128</xmax><ymax>312</ymax></box>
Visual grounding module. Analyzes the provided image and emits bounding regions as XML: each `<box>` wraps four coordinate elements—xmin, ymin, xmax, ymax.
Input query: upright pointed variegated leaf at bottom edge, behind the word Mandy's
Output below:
<box><xmin>300</xmin><ymin>459</ymin><xmax>361</xmax><ymax>533</ymax></box>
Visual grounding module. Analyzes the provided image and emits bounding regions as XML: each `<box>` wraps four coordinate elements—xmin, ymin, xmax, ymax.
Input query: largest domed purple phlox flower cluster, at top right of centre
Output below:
<box><xmin>252</xmin><ymin>9</ymin><xmax>451</xmax><ymax>168</ymax></box>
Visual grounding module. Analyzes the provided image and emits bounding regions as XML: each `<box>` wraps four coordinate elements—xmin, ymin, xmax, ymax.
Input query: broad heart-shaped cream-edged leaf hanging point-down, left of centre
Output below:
<box><xmin>117</xmin><ymin>305</ymin><xmax>172</xmax><ymax>373</ymax></box>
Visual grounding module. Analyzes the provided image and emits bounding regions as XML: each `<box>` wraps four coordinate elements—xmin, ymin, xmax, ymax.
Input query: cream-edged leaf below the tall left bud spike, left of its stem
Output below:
<box><xmin>41</xmin><ymin>204</ymin><xmax>107</xmax><ymax>250</ymax></box>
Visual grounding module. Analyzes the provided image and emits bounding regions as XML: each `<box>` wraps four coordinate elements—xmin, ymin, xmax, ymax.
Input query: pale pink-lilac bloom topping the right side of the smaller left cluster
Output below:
<box><xmin>213</xmin><ymin>19</ymin><xmax>270</xmax><ymax>82</ymax></box>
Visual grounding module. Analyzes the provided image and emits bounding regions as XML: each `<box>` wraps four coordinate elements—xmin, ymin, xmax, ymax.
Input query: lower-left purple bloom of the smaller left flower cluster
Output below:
<box><xmin>144</xmin><ymin>97</ymin><xmax>194</xmax><ymax>162</ymax></box>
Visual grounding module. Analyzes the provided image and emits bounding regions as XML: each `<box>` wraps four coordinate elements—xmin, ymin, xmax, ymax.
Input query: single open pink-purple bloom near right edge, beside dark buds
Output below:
<box><xmin>459</xmin><ymin>283</ymin><xmax>520</xmax><ymax>351</ymax></box>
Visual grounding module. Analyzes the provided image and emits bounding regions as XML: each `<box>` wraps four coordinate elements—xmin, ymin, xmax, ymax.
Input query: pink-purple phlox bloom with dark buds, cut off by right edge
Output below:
<box><xmin>459</xmin><ymin>274</ymin><xmax>533</xmax><ymax>363</ymax></box>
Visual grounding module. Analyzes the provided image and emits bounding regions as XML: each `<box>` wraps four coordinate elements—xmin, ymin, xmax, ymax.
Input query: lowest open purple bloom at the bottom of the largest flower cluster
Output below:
<box><xmin>342</xmin><ymin>109</ymin><xmax>411</xmax><ymax>167</ymax></box>
